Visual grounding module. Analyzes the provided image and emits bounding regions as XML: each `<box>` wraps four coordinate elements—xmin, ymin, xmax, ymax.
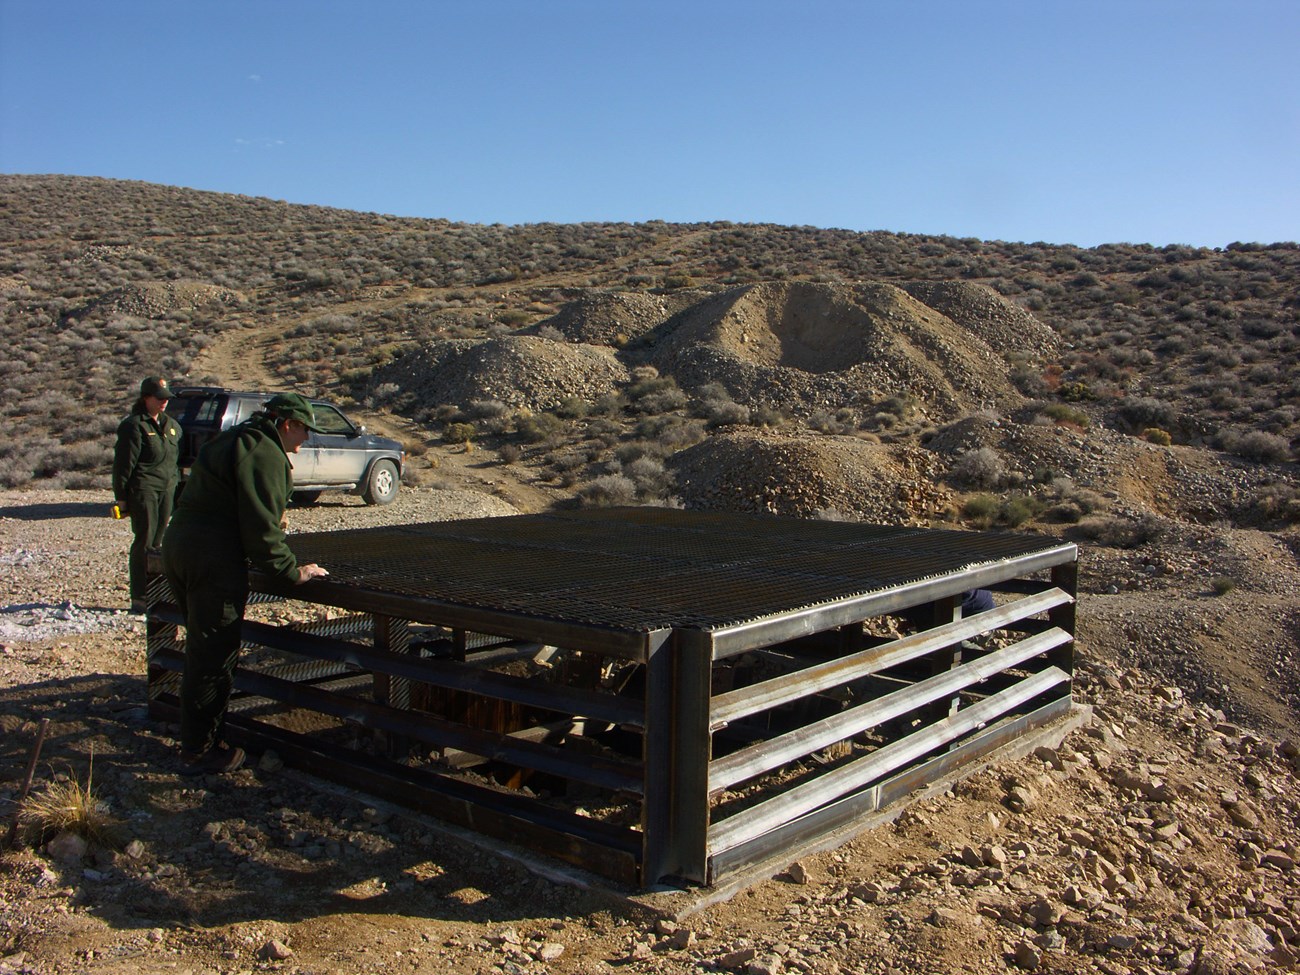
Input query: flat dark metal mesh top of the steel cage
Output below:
<box><xmin>289</xmin><ymin>507</ymin><xmax>1073</xmax><ymax>632</ymax></box>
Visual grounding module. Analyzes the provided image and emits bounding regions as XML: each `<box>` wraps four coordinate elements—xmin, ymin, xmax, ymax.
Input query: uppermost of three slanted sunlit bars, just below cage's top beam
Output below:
<box><xmin>710</xmin><ymin>589</ymin><xmax>1074</xmax><ymax>731</ymax></box>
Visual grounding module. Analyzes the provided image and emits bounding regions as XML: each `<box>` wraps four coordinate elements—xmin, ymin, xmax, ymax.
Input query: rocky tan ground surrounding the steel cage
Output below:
<box><xmin>0</xmin><ymin>483</ymin><xmax>1300</xmax><ymax>975</ymax></box>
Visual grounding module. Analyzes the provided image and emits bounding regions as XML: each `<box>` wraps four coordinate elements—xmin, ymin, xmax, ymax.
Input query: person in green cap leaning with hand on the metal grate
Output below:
<box><xmin>163</xmin><ymin>393</ymin><xmax>329</xmax><ymax>775</ymax></box>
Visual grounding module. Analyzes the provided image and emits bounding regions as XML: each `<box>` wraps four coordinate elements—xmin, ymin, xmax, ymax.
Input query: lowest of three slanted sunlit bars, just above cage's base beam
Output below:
<box><xmin>709</xmin><ymin>667</ymin><xmax>1070</xmax><ymax>852</ymax></box>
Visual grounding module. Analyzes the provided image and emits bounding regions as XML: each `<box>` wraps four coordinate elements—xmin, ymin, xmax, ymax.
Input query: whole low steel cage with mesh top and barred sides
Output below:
<box><xmin>148</xmin><ymin>507</ymin><xmax>1078</xmax><ymax>888</ymax></box>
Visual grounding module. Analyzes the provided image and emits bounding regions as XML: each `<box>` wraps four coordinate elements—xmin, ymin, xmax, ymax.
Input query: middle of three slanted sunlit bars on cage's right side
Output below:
<box><xmin>709</xmin><ymin>629</ymin><xmax>1073</xmax><ymax>793</ymax></box>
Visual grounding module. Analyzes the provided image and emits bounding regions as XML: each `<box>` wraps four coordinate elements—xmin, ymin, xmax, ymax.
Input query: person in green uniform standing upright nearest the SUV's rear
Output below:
<box><xmin>113</xmin><ymin>376</ymin><xmax>181</xmax><ymax>612</ymax></box>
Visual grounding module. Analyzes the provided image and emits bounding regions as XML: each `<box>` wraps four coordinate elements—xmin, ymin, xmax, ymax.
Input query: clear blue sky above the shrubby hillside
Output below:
<box><xmin>0</xmin><ymin>0</ymin><xmax>1300</xmax><ymax>247</ymax></box>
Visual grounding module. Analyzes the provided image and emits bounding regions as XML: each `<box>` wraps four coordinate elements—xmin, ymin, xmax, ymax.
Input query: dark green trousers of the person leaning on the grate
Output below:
<box><xmin>163</xmin><ymin>525</ymin><xmax>248</xmax><ymax>754</ymax></box>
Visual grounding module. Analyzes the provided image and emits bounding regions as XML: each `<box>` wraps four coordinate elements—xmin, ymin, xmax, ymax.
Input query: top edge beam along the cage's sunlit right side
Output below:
<box><xmin>711</xmin><ymin>545</ymin><xmax>1078</xmax><ymax>660</ymax></box>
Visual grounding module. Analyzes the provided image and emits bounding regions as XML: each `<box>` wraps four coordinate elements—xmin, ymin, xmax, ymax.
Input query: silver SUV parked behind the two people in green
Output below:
<box><xmin>166</xmin><ymin>386</ymin><xmax>406</xmax><ymax>504</ymax></box>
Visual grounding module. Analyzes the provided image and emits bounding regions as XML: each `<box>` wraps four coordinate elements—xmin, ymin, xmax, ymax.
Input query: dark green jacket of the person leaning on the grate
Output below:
<box><xmin>163</xmin><ymin>413</ymin><xmax>298</xmax><ymax>582</ymax></box>
